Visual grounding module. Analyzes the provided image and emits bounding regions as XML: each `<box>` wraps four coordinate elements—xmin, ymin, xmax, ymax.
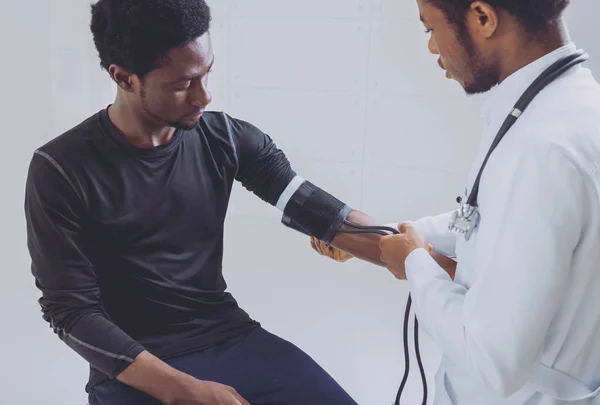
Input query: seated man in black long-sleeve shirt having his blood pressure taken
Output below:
<box><xmin>25</xmin><ymin>0</ymin><xmax>392</xmax><ymax>405</ymax></box>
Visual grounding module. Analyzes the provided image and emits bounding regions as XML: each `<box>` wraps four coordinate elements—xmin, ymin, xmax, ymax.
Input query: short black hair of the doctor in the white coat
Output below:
<box><xmin>427</xmin><ymin>0</ymin><xmax>570</xmax><ymax>34</ymax></box>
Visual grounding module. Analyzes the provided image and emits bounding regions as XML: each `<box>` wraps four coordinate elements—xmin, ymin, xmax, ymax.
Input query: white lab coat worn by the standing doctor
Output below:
<box><xmin>406</xmin><ymin>44</ymin><xmax>600</xmax><ymax>405</ymax></box>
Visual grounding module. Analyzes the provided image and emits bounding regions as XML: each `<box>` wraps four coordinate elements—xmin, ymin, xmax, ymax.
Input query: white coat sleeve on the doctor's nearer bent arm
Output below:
<box><xmin>406</xmin><ymin>144</ymin><xmax>586</xmax><ymax>396</ymax></box>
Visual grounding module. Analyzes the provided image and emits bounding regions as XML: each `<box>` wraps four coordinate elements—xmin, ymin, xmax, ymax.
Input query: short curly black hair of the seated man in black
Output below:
<box><xmin>90</xmin><ymin>0</ymin><xmax>211</xmax><ymax>78</ymax></box>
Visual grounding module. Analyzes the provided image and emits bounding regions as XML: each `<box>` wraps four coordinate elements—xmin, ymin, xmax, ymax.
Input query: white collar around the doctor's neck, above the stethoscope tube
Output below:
<box><xmin>481</xmin><ymin>42</ymin><xmax>577</xmax><ymax>126</ymax></box>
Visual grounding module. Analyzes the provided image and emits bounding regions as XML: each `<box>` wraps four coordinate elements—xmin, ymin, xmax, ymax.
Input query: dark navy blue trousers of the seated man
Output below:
<box><xmin>89</xmin><ymin>328</ymin><xmax>357</xmax><ymax>405</ymax></box>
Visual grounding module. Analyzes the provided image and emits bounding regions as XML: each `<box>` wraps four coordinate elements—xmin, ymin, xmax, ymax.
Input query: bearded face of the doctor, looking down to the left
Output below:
<box><xmin>417</xmin><ymin>0</ymin><xmax>500</xmax><ymax>94</ymax></box>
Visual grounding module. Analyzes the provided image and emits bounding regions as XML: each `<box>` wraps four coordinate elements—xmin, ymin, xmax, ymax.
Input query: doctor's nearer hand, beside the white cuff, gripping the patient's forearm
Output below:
<box><xmin>379</xmin><ymin>224</ymin><xmax>426</xmax><ymax>280</ymax></box>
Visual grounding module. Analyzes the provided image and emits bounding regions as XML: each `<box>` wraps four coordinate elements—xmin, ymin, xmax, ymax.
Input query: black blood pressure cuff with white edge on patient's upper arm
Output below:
<box><xmin>278</xmin><ymin>177</ymin><xmax>352</xmax><ymax>243</ymax></box>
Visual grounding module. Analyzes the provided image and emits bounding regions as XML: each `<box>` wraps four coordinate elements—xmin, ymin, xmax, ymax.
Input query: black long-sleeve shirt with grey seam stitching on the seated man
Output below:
<box><xmin>25</xmin><ymin>109</ymin><xmax>295</xmax><ymax>390</ymax></box>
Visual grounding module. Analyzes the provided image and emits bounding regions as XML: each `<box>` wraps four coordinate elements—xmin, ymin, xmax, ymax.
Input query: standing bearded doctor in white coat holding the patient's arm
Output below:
<box><xmin>312</xmin><ymin>0</ymin><xmax>600</xmax><ymax>405</ymax></box>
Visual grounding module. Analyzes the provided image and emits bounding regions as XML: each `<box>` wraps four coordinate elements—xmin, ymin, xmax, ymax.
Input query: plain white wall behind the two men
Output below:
<box><xmin>0</xmin><ymin>0</ymin><xmax>600</xmax><ymax>405</ymax></box>
